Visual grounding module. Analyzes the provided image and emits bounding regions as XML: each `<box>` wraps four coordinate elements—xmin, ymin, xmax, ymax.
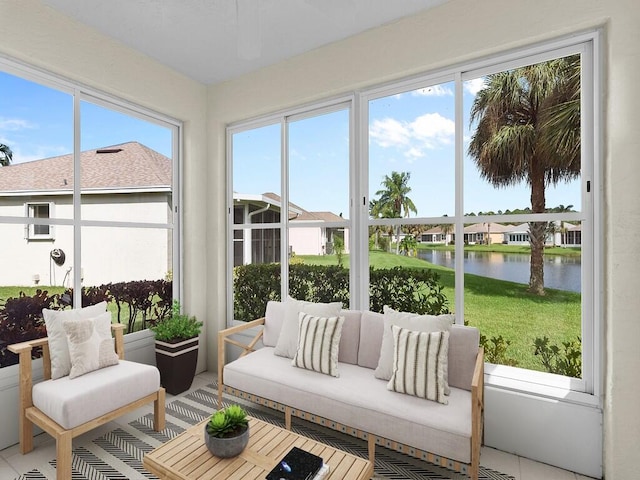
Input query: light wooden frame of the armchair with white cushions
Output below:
<box><xmin>7</xmin><ymin>324</ymin><xmax>165</xmax><ymax>480</ymax></box>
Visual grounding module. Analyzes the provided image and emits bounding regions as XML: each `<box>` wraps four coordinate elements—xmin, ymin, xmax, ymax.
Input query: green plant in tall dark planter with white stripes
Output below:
<box><xmin>149</xmin><ymin>300</ymin><xmax>202</xmax><ymax>395</ymax></box>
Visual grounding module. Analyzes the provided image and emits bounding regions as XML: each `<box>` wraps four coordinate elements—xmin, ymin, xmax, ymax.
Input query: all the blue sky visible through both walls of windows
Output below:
<box><xmin>0</xmin><ymin>65</ymin><xmax>580</xmax><ymax>218</ymax></box>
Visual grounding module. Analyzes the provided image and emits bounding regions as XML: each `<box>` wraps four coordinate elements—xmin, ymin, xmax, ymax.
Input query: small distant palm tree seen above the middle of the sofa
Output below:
<box><xmin>371</xmin><ymin>172</ymin><xmax>418</xmax><ymax>254</ymax></box>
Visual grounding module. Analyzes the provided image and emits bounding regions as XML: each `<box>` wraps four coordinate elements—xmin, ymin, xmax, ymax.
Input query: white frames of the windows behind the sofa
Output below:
<box><xmin>227</xmin><ymin>30</ymin><xmax>604</xmax><ymax>406</ymax></box>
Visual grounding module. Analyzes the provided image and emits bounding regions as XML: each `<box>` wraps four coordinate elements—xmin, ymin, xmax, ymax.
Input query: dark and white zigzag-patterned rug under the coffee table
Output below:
<box><xmin>16</xmin><ymin>384</ymin><xmax>513</xmax><ymax>480</ymax></box>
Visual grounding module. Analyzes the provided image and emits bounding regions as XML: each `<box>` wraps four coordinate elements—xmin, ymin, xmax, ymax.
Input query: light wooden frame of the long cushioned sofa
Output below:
<box><xmin>218</xmin><ymin>317</ymin><xmax>484</xmax><ymax>480</ymax></box>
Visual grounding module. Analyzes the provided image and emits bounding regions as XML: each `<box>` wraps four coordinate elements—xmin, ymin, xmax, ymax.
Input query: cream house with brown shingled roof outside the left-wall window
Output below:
<box><xmin>0</xmin><ymin>142</ymin><xmax>172</xmax><ymax>286</ymax></box>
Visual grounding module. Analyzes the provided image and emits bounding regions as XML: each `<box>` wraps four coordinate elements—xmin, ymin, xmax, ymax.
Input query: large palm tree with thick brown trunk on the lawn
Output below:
<box><xmin>469</xmin><ymin>55</ymin><xmax>580</xmax><ymax>295</ymax></box>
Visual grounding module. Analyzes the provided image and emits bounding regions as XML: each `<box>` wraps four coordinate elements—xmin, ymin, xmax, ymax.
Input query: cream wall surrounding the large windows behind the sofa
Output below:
<box><xmin>207</xmin><ymin>0</ymin><xmax>640</xmax><ymax>480</ymax></box>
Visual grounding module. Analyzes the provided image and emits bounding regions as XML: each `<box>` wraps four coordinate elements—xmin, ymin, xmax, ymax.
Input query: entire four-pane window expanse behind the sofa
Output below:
<box><xmin>229</xmin><ymin>37</ymin><xmax>601</xmax><ymax>393</ymax></box>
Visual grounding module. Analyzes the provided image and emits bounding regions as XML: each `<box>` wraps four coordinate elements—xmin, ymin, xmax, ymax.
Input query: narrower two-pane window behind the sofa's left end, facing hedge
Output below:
<box><xmin>228</xmin><ymin>102</ymin><xmax>351</xmax><ymax>321</ymax></box>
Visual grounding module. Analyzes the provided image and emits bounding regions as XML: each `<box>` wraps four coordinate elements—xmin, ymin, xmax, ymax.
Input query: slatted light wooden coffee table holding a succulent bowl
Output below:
<box><xmin>142</xmin><ymin>417</ymin><xmax>373</xmax><ymax>480</ymax></box>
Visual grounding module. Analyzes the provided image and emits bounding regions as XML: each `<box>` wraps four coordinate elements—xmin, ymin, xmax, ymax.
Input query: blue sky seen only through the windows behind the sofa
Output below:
<box><xmin>233</xmin><ymin>79</ymin><xmax>580</xmax><ymax>217</ymax></box>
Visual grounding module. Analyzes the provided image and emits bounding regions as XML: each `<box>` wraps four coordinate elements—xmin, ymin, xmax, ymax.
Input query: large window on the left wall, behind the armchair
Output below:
<box><xmin>0</xmin><ymin>60</ymin><xmax>179</xmax><ymax>366</ymax></box>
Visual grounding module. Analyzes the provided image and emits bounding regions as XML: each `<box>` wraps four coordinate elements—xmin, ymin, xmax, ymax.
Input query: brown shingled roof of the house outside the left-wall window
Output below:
<box><xmin>0</xmin><ymin>142</ymin><xmax>172</xmax><ymax>193</ymax></box>
